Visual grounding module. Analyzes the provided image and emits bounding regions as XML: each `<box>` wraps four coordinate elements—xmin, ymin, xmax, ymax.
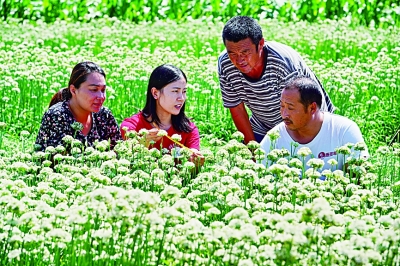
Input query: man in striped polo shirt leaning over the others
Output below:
<box><xmin>218</xmin><ymin>16</ymin><xmax>334</xmax><ymax>143</ymax></box>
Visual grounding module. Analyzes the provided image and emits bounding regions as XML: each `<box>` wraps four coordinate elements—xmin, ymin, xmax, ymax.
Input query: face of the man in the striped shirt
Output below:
<box><xmin>225</xmin><ymin>38</ymin><xmax>264</xmax><ymax>74</ymax></box>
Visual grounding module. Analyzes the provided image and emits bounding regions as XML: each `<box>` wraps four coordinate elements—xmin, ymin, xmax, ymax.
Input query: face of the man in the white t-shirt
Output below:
<box><xmin>281</xmin><ymin>89</ymin><xmax>312</xmax><ymax>131</ymax></box>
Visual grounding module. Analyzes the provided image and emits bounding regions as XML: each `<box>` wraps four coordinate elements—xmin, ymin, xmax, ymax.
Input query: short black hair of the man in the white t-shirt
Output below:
<box><xmin>284</xmin><ymin>76</ymin><xmax>322</xmax><ymax>108</ymax></box>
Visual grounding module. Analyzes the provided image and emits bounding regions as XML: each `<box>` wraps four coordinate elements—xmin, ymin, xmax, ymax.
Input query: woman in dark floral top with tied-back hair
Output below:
<box><xmin>35</xmin><ymin>62</ymin><xmax>122</xmax><ymax>151</ymax></box>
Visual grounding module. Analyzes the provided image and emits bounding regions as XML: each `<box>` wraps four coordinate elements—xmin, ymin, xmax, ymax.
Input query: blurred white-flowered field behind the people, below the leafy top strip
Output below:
<box><xmin>0</xmin><ymin>18</ymin><xmax>400</xmax><ymax>151</ymax></box>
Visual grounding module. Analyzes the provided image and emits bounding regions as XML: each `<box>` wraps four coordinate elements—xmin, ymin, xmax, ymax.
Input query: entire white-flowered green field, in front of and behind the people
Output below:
<box><xmin>0</xmin><ymin>1</ymin><xmax>400</xmax><ymax>265</ymax></box>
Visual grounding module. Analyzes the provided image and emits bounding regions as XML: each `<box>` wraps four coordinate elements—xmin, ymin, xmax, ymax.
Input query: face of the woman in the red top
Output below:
<box><xmin>152</xmin><ymin>77</ymin><xmax>186</xmax><ymax>115</ymax></box>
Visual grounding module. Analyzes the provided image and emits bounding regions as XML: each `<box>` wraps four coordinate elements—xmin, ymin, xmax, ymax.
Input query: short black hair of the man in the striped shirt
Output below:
<box><xmin>222</xmin><ymin>16</ymin><xmax>263</xmax><ymax>46</ymax></box>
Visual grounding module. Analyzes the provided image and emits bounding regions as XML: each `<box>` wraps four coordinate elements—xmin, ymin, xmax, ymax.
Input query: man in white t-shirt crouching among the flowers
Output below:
<box><xmin>261</xmin><ymin>77</ymin><xmax>369</xmax><ymax>170</ymax></box>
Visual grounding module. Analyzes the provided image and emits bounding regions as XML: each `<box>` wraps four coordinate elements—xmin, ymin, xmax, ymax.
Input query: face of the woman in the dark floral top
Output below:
<box><xmin>71</xmin><ymin>73</ymin><xmax>106</xmax><ymax>113</ymax></box>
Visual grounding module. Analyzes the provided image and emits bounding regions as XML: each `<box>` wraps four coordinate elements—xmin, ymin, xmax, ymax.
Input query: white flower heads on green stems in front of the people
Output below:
<box><xmin>0</xmin><ymin>129</ymin><xmax>400</xmax><ymax>265</ymax></box>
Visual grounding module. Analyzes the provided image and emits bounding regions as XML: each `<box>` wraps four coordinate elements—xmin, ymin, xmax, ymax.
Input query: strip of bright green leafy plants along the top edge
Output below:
<box><xmin>0</xmin><ymin>0</ymin><xmax>400</xmax><ymax>27</ymax></box>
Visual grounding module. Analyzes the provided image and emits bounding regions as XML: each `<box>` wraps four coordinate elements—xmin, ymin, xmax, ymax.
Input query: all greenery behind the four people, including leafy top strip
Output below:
<box><xmin>0</xmin><ymin>0</ymin><xmax>400</xmax><ymax>149</ymax></box>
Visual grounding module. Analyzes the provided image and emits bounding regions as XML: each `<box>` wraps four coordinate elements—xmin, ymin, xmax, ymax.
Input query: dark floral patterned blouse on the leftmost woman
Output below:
<box><xmin>35</xmin><ymin>101</ymin><xmax>122</xmax><ymax>151</ymax></box>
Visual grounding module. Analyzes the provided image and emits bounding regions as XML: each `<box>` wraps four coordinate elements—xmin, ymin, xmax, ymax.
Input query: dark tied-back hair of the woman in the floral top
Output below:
<box><xmin>49</xmin><ymin>61</ymin><xmax>106</xmax><ymax>108</ymax></box>
